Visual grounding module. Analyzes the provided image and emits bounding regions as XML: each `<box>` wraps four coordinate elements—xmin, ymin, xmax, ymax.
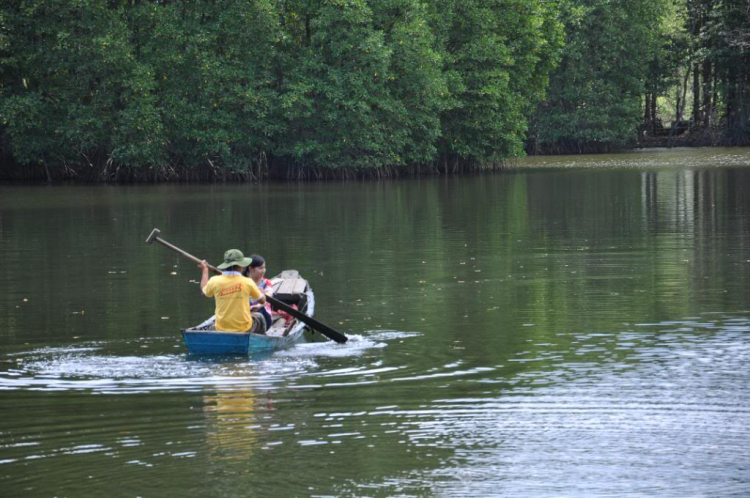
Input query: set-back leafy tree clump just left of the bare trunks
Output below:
<box><xmin>531</xmin><ymin>0</ymin><xmax>663</xmax><ymax>152</ymax></box>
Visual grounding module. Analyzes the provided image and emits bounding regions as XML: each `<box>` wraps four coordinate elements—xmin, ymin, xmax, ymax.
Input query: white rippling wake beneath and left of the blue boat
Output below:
<box><xmin>0</xmin><ymin>331</ymin><xmax>419</xmax><ymax>394</ymax></box>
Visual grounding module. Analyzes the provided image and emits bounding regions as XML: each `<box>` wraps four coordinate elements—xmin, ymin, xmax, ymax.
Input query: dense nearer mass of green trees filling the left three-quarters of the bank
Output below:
<box><xmin>0</xmin><ymin>0</ymin><xmax>562</xmax><ymax>180</ymax></box>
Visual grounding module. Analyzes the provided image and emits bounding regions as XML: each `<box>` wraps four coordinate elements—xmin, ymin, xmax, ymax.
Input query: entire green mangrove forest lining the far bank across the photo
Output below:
<box><xmin>0</xmin><ymin>0</ymin><xmax>750</xmax><ymax>182</ymax></box>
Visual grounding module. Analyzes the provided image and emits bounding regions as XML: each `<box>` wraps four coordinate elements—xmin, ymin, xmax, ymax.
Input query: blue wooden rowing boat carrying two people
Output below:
<box><xmin>181</xmin><ymin>270</ymin><xmax>315</xmax><ymax>355</ymax></box>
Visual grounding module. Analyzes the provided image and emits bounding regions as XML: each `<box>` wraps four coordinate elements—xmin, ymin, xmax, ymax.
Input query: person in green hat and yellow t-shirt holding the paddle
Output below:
<box><xmin>198</xmin><ymin>249</ymin><xmax>266</xmax><ymax>334</ymax></box>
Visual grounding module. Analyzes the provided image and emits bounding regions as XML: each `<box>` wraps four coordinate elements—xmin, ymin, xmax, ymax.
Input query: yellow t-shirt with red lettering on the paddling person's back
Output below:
<box><xmin>203</xmin><ymin>275</ymin><xmax>263</xmax><ymax>332</ymax></box>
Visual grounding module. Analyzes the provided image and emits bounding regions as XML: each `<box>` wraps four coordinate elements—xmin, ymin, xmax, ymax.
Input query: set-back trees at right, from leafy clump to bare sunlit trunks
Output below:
<box><xmin>527</xmin><ymin>0</ymin><xmax>750</xmax><ymax>153</ymax></box>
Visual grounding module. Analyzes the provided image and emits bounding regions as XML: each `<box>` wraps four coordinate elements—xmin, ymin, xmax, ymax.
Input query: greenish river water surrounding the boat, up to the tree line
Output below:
<box><xmin>0</xmin><ymin>149</ymin><xmax>750</xmax><ymax>497</ymax></box>
